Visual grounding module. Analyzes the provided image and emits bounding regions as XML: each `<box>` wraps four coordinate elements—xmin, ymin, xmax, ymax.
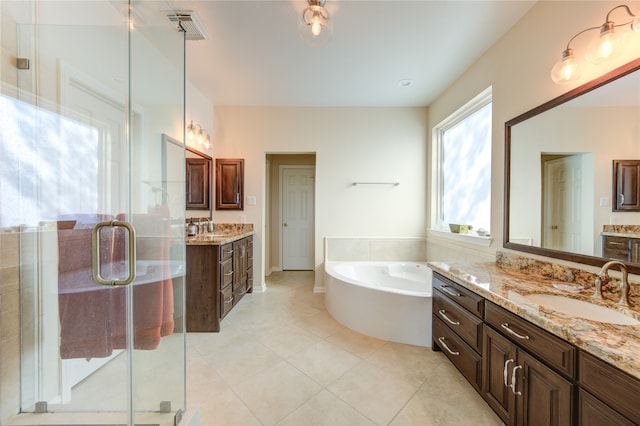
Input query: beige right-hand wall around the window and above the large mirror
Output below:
<box><xmin>427</xmin><ymin>1</ymin><xmax>640</xmax><ymax>266</ymax></box>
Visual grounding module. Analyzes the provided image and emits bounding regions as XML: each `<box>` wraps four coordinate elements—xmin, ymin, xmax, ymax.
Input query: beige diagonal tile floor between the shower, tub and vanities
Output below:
<box><xmin>187</xmin><ymin>272</ymin><xmax>501</xmax><ymax>426</ymax></box>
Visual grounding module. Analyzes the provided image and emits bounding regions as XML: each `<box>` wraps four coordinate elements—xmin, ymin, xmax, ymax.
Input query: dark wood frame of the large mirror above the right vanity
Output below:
<box><xmin>502</xmin><ymin>59</ymin><xmax>640</xmax><ymax>274</ymax></box>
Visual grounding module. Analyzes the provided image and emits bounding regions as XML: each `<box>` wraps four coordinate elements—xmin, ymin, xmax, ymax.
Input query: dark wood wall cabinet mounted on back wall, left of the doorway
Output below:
<box><xmin>216</xmin><ymin>158</ymin><xmax>244</xmax><ymax>210</ymax></box>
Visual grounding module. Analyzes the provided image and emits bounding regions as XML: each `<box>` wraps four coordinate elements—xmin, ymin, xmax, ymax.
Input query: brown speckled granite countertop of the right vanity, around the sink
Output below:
<box><xmin>429</xmin><ymin>262</ymin><xmax>640</xmax><ymax>379</ymax></box>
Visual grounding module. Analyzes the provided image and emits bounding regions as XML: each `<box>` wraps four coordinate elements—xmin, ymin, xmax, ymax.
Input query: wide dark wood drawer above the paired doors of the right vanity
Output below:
<box><xmin>484</xmin><ymin>302</ymin><xmax>577</xmax><ymax>378</ymax></box>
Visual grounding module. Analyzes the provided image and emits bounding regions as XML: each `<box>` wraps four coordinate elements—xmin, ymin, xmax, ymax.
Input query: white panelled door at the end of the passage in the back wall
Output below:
<box><xmin>280</xmin><ymin>166</ymin><xmax>315</xmax><ymax>270</ymax></box>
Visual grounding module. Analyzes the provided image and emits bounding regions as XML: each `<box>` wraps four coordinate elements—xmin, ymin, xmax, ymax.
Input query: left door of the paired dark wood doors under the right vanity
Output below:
<box><xmin>482</xmin><ymin>326</ymin><xmax>517</xmax><ymax>425</ymax></box>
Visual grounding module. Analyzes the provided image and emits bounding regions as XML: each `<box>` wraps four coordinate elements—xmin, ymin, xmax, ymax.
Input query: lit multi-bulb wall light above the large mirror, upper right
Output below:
<box><xmin>551</xmin><ymin>4</ymin><xmax>640</xmax><ymax>84</ymax></box>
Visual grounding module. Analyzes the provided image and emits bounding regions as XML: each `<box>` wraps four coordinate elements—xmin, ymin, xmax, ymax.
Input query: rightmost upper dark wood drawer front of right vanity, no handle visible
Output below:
<box><xmin>578</xmin><ymin>351</ymin><xmax>640</xmax><ymax>424</ymax></box>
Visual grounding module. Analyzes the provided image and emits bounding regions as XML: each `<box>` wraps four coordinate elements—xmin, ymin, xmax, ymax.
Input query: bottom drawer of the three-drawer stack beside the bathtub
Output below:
<box><xmin>432</xmin><ymin>315</ymin><xmax>482</xmax><ymax>392</ymax></box>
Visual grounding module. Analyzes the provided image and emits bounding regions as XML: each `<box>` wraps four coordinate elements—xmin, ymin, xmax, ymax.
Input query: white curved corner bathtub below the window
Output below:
<box><xmin>325</xmin><ymin>261</ymin><xmax>431</xmax><ymax>347</ymax></box>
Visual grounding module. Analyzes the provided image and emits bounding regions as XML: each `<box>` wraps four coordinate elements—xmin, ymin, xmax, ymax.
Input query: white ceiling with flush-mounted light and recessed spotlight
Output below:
<box><xmin>174</xmin><ymin>0</ymin><xmax>535</xmax><ymax>106</ymax></box>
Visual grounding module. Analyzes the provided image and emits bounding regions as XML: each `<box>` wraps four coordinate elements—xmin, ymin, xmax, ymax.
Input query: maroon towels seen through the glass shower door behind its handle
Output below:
<box><xmin>58</xmin><ymin>214</ymin><xmax>174</xmax><ymax>359</ymax></box>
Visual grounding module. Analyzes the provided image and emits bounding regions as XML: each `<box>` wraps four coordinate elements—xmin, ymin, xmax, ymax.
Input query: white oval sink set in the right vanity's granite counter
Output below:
<box><xmin>525</xmin><ymin>294</ymin><xmax>640</xmax><ymax>325</ymax></box>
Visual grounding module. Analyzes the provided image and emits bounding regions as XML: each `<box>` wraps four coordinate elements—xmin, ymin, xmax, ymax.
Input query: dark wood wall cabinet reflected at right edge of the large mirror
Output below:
<box><xmin>612</xmin><ymin>160</ymin><xmax>640</xmax><ymax>212</ymax></box>
